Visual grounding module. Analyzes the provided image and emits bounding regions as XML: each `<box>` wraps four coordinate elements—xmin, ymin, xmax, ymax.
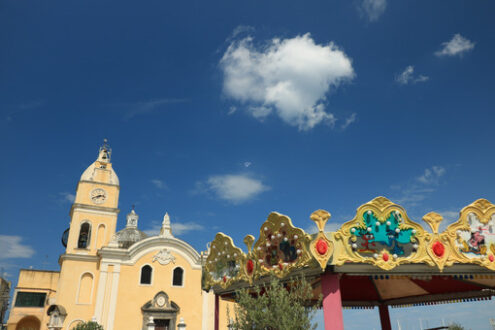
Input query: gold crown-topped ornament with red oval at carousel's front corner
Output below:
<box><xmin>309</xmin><ymin>210</ymin><xmax>334</xmax><ymax>271</ymax></box>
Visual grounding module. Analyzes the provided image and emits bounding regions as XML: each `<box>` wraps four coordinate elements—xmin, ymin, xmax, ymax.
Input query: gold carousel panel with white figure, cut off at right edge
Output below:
<box><xmin>446</xmin><ymin>199</ymin><xmax>495</xmax><ymax>270</ymax></box>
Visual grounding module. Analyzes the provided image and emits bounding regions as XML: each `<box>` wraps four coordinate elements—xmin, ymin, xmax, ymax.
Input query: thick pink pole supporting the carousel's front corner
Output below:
<box><xmin>321</xmin><ymin>273</ymin><xmax>344</xmax><ymax>330</ymax></box>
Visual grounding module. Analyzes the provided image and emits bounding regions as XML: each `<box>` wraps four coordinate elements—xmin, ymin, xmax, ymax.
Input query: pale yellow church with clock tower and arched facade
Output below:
<box><xmin>7</xmin><ymin>142</ymin><xmax>231</xmax><ymax>330</ymax></box>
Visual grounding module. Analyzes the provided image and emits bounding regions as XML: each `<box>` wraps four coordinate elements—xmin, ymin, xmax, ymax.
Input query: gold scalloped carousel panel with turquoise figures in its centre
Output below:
<box><xmin>333</xmin><ymin>197</ymin><xmax>425</xmax><ymax>270</ymax></box>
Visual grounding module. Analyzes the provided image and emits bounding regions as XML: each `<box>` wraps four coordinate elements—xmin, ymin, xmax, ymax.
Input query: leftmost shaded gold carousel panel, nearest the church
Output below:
<box><xmin>203</xmin><ymin>233</ymin><xmax>246</xmax><ymax>288</ymax></box>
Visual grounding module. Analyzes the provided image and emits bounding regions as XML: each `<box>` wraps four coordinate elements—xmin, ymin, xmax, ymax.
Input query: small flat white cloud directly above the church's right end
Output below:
<box><xmin>196</xmin><ymin>174</ymin><xmax>270</xmax><ymax>204</ymax></box>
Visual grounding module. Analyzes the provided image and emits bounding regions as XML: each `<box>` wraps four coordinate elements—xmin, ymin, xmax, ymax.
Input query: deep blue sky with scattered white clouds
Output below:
<box><xmin>0</xmin><ymin>0</ymin><xmax>495</xmax><ymax>329</ymax></box>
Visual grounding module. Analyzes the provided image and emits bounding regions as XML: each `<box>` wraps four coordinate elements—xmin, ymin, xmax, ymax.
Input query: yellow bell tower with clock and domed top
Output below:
<box><xmin>66</xmin><ymin>139</ymin><xmax>120</xmax><ymax>255</ymax></box>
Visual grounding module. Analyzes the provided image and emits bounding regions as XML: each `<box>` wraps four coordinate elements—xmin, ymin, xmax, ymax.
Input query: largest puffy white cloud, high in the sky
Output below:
<box><xmin>220</xmin><ymin>33</ymin><xmax>354</xmax><ymax>130</ymax></box>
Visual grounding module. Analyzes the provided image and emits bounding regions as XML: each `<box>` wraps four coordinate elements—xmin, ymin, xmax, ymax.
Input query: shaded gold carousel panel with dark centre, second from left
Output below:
<box><xmin>253</xmin><ymin>212</ymin><xmax>311</xmax><ymax>278</ymax></box>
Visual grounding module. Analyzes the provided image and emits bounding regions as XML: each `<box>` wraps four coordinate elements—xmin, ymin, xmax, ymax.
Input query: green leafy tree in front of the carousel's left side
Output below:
<box><xmin>227</xmin><ymin>278</ymin><xmax>321</xmax><ymax>330</ymax></box>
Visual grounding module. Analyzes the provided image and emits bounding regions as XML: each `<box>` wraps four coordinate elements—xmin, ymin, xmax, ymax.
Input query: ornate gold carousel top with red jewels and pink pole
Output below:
<box><xmin>203</xmin><ymin>197</ymin><xmax>495</xmax><ymax>330</ymax></box>
